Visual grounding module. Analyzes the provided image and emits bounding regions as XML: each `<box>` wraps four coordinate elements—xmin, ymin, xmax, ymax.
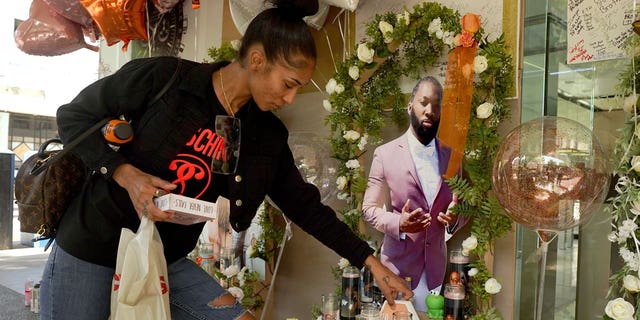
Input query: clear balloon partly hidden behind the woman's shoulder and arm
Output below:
<box><xmin>289</xmin><ymin>132</ymin><xmax>337</xmax><ymax>204</ymax></box>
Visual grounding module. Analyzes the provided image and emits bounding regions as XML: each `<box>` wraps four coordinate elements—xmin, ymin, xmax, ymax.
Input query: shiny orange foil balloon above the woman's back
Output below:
<box><xmin>80</xmin><ymin>0</ymin><xmax>149</xmax><ymax>50</ymax></box>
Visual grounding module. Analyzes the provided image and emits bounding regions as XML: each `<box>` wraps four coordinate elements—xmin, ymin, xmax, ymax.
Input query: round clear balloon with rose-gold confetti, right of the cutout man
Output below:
<box><xmin>492</xmin><ymin>117</ymin><xmax>610</xmax><ymax>236</ymax></box>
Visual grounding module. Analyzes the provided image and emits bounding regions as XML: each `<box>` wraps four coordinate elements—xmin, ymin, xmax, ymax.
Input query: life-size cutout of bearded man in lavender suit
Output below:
<box><xmin>362</xmin><ymin>77</ymin><xmax>466</xmax><ymax>311</ymax></box>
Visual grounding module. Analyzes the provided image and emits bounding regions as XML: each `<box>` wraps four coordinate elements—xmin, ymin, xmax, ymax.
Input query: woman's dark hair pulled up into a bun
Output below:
<box><xmin>238</xmin><ymin>0</ymin><xmax>318</xmax><ymax>67</ymax></box>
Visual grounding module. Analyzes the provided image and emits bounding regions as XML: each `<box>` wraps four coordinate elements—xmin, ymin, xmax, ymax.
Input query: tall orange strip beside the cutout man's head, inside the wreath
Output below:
<box><xmin>438</xmin><ymin>45</ymin><xmax>477</xmax><ymax>179</ymax></box>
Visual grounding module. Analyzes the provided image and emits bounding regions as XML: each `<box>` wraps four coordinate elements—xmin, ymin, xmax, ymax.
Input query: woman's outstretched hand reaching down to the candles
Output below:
<box><xmin>364</xmin><ymin>255</ymin><xmax>413</xmax><ymax>306</ymax></box>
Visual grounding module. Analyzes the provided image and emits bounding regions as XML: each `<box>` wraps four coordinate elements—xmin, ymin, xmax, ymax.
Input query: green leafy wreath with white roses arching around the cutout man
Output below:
<box><xmin>209</xmin><ymin>2</ymin><xmax>514</xmax><ymax>319</ymax></box>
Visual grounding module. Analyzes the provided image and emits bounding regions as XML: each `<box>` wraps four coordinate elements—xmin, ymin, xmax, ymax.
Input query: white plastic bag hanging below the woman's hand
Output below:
<box><xmin>110</xmin><ymin>217</ymin><xmax>171</xmax><ymax>320</ymax></box>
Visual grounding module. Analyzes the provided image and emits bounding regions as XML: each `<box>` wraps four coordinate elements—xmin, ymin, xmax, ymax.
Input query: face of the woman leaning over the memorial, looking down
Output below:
<box><xmin>249</xmin><ymin>55</ymin><xmax>315</xmax><ymax>111</ymax></box>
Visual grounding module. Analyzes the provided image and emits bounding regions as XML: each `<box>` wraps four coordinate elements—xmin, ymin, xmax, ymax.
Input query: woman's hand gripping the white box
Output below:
<box><xmin>111</xmin><ymin>163</ymin><xmax>177</xmax><ymax>221</ymax></box>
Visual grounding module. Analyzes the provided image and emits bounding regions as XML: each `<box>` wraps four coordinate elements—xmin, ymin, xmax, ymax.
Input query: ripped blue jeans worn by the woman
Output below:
<box><xmin>40</xmin><ymin>245</ymin><xmax>247</xmax><ymax>320</ymax></box>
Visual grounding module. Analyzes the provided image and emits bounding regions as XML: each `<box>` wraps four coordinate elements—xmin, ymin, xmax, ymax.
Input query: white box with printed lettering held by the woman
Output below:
<box><xmin>153</xmin><ymin>193</ymin><xmax>217</xmax><ymax>225</ymax></box>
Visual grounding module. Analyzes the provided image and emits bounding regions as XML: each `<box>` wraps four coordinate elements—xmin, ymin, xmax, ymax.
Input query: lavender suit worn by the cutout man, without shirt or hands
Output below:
<box><xmin>362</xmin><ymin>133</ymin><xmax>466</xmax><ymax>289</ymax></box>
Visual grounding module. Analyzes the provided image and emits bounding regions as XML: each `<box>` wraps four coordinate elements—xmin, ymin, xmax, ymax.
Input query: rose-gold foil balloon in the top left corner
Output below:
<box><xmin>14</xmin><ymin>0</ymin><xmax>98</xmax><ymax>56</ymax></box>
